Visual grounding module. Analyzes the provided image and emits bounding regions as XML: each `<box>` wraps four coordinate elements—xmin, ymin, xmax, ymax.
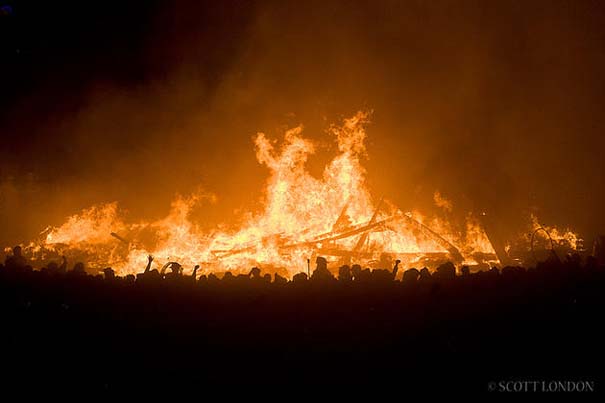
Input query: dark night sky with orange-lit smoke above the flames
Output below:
<box><xmin>0</xmin><ymin>0</ymin><xmax>605</xmax><ymax>243</ymax></box>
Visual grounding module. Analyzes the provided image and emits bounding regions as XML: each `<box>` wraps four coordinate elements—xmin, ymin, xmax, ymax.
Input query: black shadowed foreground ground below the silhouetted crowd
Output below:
<box><xmin>0</xmin><ymin>260</ymin><xmax>605</xmax><ymax>400</ymax></box>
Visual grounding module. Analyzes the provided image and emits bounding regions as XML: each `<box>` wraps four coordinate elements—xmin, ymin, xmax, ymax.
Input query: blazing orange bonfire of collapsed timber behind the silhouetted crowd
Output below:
<box><xmin>9</xmin><ymin>112</ymin><xmax>575</xmax><ymax>276</ymax></box>
